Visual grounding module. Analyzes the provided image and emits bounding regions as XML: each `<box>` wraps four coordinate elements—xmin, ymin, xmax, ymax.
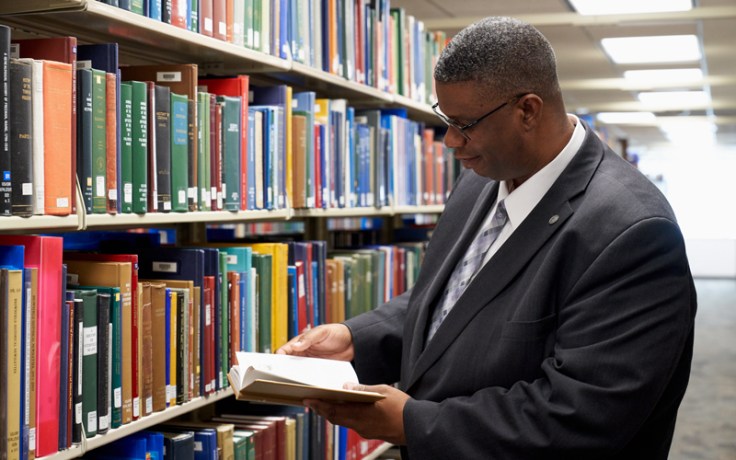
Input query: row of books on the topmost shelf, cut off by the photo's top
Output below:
<box><xmin>100</xmin><ymin>0</ymin><xmax>446</xmax><ymax>103</ymax></box>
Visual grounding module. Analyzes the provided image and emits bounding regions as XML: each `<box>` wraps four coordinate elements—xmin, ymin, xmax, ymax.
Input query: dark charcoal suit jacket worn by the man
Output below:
<box><xmin>346</xmin><ymin>124</ymin><xmax>696</xmax><ymax>460</ymax></box>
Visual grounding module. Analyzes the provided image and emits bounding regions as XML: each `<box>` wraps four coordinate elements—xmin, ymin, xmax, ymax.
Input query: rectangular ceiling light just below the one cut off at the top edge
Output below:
<box><xmin>601</xmin><ymin>35</ymin><xmax>701</xmax><ymax>64</ymax></box>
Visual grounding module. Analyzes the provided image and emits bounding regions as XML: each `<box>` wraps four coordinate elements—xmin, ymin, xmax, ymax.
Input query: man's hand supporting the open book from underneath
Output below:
<box><xmin>304</xmin><ymin>384</ymin><xmax>409</xmax><ymax>445</ymax></box>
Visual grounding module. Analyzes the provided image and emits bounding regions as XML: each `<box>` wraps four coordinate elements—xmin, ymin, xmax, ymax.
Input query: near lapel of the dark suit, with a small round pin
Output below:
<box><xmin>402</xmin><ymin>126</ymin><xmax>605</xmax><ymax>391</ymax></box>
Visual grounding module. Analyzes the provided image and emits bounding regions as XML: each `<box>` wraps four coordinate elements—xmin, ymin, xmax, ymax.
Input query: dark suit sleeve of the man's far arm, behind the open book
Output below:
<box><xmin>345</xmin><ymin>290</ymin><xmax>411</xmax><ymax>385</ymax></box>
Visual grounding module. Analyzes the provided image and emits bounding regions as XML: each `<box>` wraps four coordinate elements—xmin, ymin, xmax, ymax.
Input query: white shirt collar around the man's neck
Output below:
<box><xmin>496</xmin><ymin>114</ymin><xmax>585</xmax><ymax>229</ymax></box>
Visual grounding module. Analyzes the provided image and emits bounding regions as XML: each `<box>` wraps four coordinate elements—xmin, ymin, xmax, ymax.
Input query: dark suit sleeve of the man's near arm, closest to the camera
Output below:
<box><xmin>404</xmin><ymin>218</ymin><xmax>695</xmax><ymax>459</ymax></box>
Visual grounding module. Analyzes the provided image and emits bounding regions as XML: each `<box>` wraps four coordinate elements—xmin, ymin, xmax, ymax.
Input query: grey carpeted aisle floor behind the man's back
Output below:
<box><xmin>670</xmin><ymin>279</ymin><xmax>736</xmax><ymax>460</ymax></box>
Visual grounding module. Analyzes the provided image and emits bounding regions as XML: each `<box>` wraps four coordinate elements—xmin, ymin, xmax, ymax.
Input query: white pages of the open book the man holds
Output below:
<box><xmin>231</xmin><ymin>352</ymin><xmax>358</xmax><ymax>390</ymax></box>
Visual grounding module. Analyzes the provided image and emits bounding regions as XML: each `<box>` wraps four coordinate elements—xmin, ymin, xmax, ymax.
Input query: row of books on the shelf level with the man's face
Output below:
<box><xmin>0</xmin><ymin>26</ymin><xmax>454</xmax><ymax>216</ymax></box>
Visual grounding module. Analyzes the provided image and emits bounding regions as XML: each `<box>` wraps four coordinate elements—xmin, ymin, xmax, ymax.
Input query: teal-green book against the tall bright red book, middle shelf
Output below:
<box><xmin>217</xmin><ymin>96</ymin><xmax>242</xmax><ymax>211</ymax></box>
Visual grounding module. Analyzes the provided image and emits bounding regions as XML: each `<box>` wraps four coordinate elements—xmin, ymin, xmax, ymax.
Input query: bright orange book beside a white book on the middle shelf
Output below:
<box><xmin>43</xmin><ymin>61</ymin><xmax>73</xmax><ymax>216</ymax></box>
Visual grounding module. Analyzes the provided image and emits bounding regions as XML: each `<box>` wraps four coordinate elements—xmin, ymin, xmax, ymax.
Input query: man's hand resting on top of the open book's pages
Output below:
<box><xmin>276</xmin><ymin>324</ymin><xmax>354</xmax><ymax>361</ymax></box>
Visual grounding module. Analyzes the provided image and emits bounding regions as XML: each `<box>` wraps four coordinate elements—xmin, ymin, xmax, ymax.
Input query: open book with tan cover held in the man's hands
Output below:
<box><xmin>227</xmin><ymin>352</ymin><xmax>384</xmax><ymax>406</ymax></box>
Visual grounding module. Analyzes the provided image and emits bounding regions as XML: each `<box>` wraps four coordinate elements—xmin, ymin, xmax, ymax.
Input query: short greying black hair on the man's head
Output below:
<box><xmin>434</xmin><ymin>17</ymin><xmax>560</xmax><ymax>98</ymax></box>
